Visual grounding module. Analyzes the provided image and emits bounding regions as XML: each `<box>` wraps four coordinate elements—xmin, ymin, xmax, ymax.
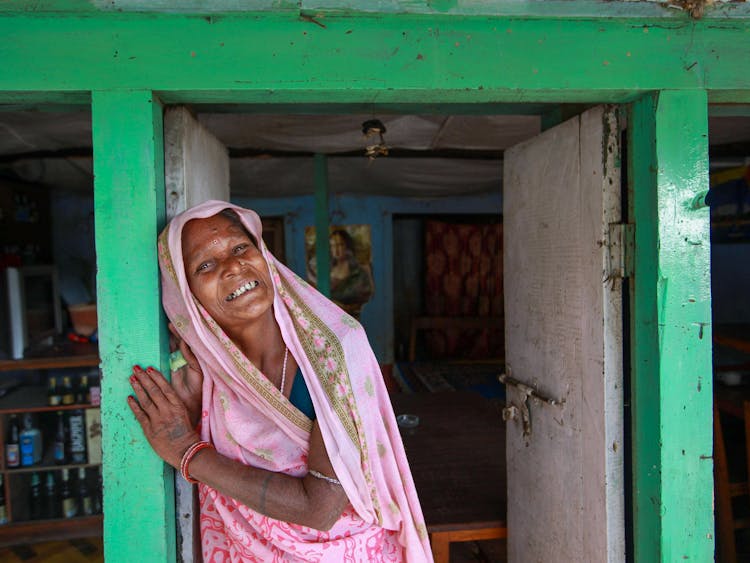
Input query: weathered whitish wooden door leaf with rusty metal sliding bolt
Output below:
<box><xmin>503</xmin><ymin>107</ymin><xmax>625</xmax><ymax>562</ymax></box>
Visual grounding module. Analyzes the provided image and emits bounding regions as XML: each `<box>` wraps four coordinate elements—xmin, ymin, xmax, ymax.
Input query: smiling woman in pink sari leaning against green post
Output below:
<box><xmin>128</xmin><ymin>201</ymin><xmax>432</xmax><ymax>562</ymax></box>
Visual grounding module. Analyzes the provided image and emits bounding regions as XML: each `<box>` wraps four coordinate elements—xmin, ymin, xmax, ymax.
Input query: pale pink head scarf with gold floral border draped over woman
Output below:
<box><xmin>159</xmin><ymin>201</ymin><xmax>432</xmax><ymax>562</ymax></box>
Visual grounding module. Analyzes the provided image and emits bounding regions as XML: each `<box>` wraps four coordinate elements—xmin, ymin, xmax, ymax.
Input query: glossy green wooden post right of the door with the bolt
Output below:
<box><xmin>629</xmin><ymin>90</ymin><xmax>714</xmax><ymax>562</ymax></box>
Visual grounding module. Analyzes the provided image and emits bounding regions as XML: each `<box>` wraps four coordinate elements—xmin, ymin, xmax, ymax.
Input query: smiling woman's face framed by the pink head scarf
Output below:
<box><xmin>182</xmin><ymin>215</ymin><xmax>273</xmax><ymax>334</ymax></box>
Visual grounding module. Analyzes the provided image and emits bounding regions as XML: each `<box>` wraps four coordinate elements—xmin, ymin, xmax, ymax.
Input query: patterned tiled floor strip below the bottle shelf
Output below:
<box><xmin>0</xmin><ymin>538</ymin><xmax>104</xmax><ymax>563</ymax></box>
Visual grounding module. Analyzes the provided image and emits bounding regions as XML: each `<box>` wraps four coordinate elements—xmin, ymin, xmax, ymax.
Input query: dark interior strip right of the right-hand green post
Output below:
<box><xmin>706</xmin><ymin>106</ymin><xmax>750</xmax><ymax>561</ymax></box>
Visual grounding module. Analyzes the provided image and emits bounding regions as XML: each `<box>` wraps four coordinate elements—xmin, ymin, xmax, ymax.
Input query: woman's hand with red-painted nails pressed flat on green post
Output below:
<box><xmin>128</xmin><ymin>366</ymin><xmax>200</xmax><ymax>469</ymax></box>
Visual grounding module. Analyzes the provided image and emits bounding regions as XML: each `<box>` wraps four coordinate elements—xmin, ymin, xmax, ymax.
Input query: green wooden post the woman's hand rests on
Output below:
<box><xmin>92</xmin><ymin>91</ymin><xmax>175</xmax><ymax>563</ymax></box>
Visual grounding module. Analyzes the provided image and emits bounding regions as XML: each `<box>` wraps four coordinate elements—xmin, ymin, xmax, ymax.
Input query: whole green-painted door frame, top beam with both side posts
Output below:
<box><xmin>0</xmin><ymin>6</ymin><xmax>750</xmax><ymax>563</ymax></box>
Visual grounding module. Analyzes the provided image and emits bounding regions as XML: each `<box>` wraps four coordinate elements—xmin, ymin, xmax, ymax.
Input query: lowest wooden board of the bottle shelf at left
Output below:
<box><xmin>0</xmin><ymin>514</ymin><xmax>103</xmax><ymax>547</ymax></box>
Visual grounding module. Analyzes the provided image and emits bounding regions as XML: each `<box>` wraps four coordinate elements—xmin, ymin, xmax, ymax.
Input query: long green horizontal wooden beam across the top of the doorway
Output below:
<box><xmin>0</xmin><ymin>12</ymin><xmax>750</xmax><ymax>104</ymax></box>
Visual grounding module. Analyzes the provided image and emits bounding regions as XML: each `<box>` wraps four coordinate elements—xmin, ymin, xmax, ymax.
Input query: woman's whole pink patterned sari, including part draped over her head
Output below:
<box><xmin>159</xmin><ymin>201</ymin><xmax>432</xmax><ymax>563</ymax></box>
